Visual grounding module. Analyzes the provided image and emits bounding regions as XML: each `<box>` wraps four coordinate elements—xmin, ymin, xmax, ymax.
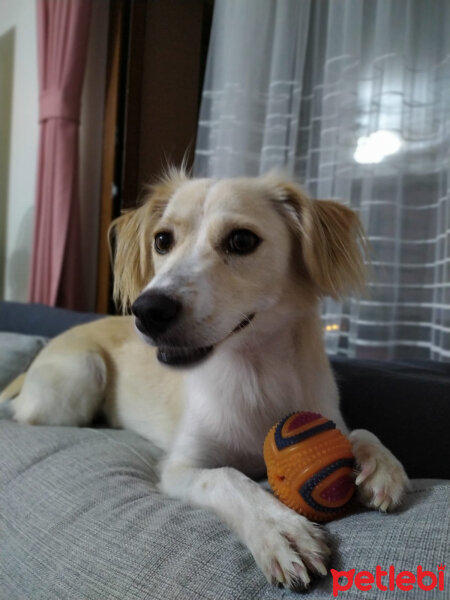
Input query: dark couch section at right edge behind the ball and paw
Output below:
<box><xmin>331</xmin><ymin>357</ymin><xmax>450</xmax><ymax>479</ymax></box>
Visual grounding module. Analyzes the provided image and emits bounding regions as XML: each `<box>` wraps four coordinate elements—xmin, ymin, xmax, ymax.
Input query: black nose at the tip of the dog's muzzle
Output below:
<box><xmin>131</xmin><ymin>290</ymin><xmax>181</xmax><ymax>338</ymax></box>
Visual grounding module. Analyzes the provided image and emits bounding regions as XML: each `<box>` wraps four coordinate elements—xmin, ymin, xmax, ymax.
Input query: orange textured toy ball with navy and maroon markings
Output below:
<box><xmin>264</xmin><ymin>412</ymin><xmax>355</xmax><ymax>521</ymax></box>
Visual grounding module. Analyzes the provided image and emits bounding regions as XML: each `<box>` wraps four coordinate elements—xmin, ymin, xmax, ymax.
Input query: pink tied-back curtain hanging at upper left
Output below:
<box><xmin>29</xmin><ymin>0</ymin><xmax>91</xmax><ymax>309</ymax></box>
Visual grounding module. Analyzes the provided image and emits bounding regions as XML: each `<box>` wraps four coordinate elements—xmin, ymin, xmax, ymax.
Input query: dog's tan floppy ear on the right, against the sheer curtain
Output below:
<box><xmin>268</xmin><ymin>182</ymin><xmax>367</xmax><ymax>299</ymax></box>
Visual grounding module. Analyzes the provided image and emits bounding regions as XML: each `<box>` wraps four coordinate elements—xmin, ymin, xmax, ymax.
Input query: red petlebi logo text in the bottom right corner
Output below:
<box><xmin>330</xmin><ymin>564</ymin><xmax>445</xmax><ymax>600</ymax></box>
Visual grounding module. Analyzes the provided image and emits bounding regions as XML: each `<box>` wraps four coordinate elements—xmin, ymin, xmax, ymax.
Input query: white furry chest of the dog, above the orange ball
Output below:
<box><xmin>188</xmin><ymin>357</ymin><xmax>302</xmax><ymax>464</ymax></box>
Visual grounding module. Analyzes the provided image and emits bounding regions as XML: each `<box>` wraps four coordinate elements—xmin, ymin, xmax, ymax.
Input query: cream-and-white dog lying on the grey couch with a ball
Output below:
<box><xmin>2</xmin><ymin>169</ymin><xmax>408</xmax><ymax>589</ymax></box>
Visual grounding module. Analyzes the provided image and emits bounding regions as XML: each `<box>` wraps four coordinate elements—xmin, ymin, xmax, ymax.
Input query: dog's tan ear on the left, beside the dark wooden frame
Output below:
<box><xmin>108</xmin><ymin>168</ymin><xmax>187</xmax><ymax>314</ymax></box>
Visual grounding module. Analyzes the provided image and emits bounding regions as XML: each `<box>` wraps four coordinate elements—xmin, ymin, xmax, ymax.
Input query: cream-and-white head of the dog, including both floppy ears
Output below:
<box><xmin>113</xmin><ymin>171</ymin><xmax>364</xmax><ymax>365</ymax></box>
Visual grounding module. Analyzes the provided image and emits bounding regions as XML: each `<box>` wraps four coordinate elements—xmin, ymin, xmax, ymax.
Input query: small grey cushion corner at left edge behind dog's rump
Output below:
<box><xmin>0</xmin><ymin>331</ymin><xmax>47</xmax><ymax>391</ymax></box>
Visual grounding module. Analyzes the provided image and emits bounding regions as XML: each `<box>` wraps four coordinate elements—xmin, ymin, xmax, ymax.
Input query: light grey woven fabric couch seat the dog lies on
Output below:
<box><xmin>0</xmin><ymin>420</ymin><xmax>450</xmax><ymax>600</ymax></box>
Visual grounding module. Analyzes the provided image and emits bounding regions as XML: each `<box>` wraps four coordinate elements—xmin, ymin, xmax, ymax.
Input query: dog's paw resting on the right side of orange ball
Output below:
<box><xmin>350</xmin><ymin>429</ymin><xmax>410</xmax><ymax>512</ymax></box>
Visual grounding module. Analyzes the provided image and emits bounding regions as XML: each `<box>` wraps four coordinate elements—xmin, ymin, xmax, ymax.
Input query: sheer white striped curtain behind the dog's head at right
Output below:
<box><xmin>195</xmin><ymin>0</ymin><xmax>450</xmax><ymax>360</ymax></box>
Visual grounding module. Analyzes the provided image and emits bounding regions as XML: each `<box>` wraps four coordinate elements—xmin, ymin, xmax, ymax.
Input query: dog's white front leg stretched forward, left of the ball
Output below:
<box><xmin>161</xmin><ymin>448</ymin><xmax>329</xmax><ymax>589</ymax></box>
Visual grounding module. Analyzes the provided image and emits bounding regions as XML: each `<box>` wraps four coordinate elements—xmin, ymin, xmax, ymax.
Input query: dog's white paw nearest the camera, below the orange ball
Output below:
<box><xmin>249</xmin><ymin>504</ymin><xmax>330</xmax><ymax>590</ymax></box>
